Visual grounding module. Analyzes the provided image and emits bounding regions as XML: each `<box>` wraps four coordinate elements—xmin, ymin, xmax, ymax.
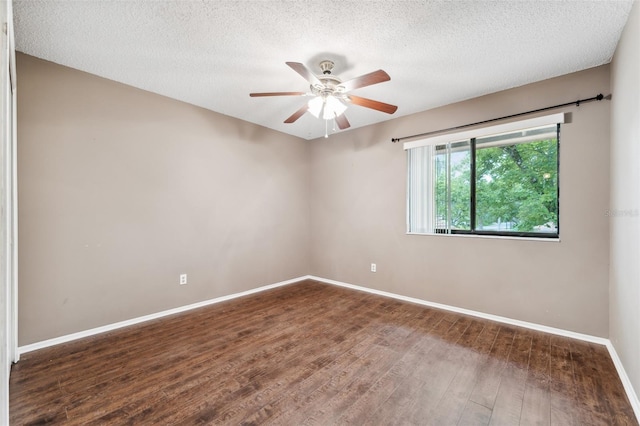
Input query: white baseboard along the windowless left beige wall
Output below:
<box><xmin>18</xmin><ymin>275</ymin><xmax>309</xmax><ymax>357</ymax></box>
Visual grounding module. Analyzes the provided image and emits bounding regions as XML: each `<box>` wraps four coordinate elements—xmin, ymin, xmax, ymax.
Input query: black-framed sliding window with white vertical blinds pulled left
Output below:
<box><xmin>405</xmin><ymin>114</ymin><xmax>564</xmax><ymax>238</ymax></box>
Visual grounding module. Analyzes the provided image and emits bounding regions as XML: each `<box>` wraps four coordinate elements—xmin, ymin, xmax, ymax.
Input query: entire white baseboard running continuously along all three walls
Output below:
<box><xmin>18</xmin><ymin>275</ymin><xmax>640</xmax><ymax>419</ymax></box>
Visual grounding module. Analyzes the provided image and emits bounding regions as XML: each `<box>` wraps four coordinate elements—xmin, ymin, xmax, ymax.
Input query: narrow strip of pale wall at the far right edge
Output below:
<box><xmin>609</xmin><ymin>2</ymin><xmax>640</xmax><ymax>403</ymax></box>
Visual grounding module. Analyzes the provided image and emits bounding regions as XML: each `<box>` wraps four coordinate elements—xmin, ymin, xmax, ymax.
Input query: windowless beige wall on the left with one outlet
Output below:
<box><xmin>18</xmin><ymin>54</ymin><xmax>309</xmax><ymax>345</ymax></box>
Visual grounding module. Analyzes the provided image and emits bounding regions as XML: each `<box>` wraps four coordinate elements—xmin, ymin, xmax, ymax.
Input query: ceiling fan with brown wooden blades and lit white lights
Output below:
<box><xmin>249</xmin><ymin>60</ymin><xmax>398</xmax><ymax>137</ymax></box>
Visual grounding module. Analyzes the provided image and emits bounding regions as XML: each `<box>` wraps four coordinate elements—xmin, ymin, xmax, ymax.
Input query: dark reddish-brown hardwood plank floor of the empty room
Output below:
<box><xmin>10</xmin><ymin>281</ymin><xmax>638</xmax><ymax>425</ymax></box>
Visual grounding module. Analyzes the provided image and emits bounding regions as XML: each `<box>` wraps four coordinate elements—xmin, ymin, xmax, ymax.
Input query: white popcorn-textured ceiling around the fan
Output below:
<box><xmin>14</xmin><ymin>0</ymin><xmax>633</xmax><ymax>139</ymax></box>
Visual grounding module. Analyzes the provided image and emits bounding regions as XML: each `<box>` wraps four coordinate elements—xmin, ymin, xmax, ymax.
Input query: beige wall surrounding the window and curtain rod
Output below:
<box><xmin>311</xmin><ymin>66</ymin><xmax>610</xmax><ymax>337</ymax></box>
